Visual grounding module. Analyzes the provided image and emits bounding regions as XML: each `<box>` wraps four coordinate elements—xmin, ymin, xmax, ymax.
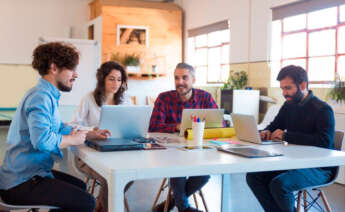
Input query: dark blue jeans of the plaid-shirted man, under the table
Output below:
<box><xmin>170</xmin><ymin>175</ymin><xmax>210</xmax><ymax>210</ymax></box>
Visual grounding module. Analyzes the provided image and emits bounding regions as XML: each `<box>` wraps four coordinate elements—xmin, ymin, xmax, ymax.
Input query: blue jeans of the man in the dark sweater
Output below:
<box><xmin>247</xmin><ymin>168</ymin><xmax>332</xmax><ymax>212</ymax></box>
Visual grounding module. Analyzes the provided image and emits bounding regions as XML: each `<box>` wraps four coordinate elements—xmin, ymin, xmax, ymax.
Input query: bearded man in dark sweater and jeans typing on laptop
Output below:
<box><xmin>247</xmin><ymin>65</ymin><xmax>334</xmax><ymax>212</ymax></box>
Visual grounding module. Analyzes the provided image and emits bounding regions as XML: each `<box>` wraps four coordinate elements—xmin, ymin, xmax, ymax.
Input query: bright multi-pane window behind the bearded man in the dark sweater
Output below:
<box><xmin>271</xmin><ymin>5</ymin><xmax>345</xmax><ymax>85</ymax></box>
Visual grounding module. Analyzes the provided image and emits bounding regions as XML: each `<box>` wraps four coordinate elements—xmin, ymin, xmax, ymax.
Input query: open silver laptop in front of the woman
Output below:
<box><xmin>100</xmin><ymin>105</ymin><xmax>153</xmax><ymax>139</ymax></box>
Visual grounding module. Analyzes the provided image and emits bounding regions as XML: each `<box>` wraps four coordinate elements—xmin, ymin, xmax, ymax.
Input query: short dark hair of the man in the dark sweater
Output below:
<box><xmin>277</xmin><ymin>65</ymin><xmax>308</xmax><ymax>88</ymax></box>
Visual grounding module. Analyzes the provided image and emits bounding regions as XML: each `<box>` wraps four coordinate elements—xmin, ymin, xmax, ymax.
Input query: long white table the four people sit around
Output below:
<box><xmin>72</xmin><ymin>136</ymin><xmax>345</xmax><ymax>212</ymax></box>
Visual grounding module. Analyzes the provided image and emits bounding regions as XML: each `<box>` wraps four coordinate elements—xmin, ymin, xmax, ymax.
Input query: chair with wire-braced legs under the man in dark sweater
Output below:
<box><xmin>297</xmin><ymin>131</ymin><xmax>344</xmax><ymax>212</ymax></box>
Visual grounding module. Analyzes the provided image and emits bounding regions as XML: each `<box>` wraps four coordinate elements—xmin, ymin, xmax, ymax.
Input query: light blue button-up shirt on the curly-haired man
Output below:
<box><xmin>0</xmin><ymin>79</ymin><xmax>72</xmax><ymax>190</ymax></box>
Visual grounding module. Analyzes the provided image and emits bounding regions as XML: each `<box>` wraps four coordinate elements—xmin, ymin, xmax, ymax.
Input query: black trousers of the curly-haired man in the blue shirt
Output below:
<box><xmin>1</xmin><ymin>170</ymin><xmax>95</xmax><ymax>212</ymax></box>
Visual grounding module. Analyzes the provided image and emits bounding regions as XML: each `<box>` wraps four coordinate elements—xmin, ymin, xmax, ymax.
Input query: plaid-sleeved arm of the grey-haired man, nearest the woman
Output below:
<box><xmin>149</xmin><ymin>95</ymin><xmax>177</xmax><ymax>133</ymax></box>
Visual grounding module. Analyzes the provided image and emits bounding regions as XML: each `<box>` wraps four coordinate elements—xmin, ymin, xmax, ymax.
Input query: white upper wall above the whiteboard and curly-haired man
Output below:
<box><xmin>0</xmin><ymin>0</ymin><xmax>91</xmax><ymax>64</ymax></box>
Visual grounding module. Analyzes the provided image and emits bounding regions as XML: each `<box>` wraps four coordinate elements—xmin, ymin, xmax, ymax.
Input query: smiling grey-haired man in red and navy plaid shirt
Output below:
<box><xmin>149</xmin><ymin>63</ymin><xmax>218</xmax><ymax>212</ymax></box>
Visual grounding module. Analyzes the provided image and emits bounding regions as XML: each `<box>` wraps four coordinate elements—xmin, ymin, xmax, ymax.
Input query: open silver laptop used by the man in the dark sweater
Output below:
<box><xmin>231</xmin><ymin>113</ymin><xmax>283</xmax><ymax>144</ymax></box>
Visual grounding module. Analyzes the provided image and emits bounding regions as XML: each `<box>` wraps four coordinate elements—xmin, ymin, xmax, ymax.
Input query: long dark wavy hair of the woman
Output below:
<box><xmin>93</xmin><ymin>61</ymin><xmax>127</xmax><ymax>107</ymax></box>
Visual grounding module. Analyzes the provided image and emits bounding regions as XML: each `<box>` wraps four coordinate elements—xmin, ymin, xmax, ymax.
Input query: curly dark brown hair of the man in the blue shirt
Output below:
<box><xmin>32</xmin><ymin>42</ymin><xmax>79</xmax><ymax>76</ymax></box>
